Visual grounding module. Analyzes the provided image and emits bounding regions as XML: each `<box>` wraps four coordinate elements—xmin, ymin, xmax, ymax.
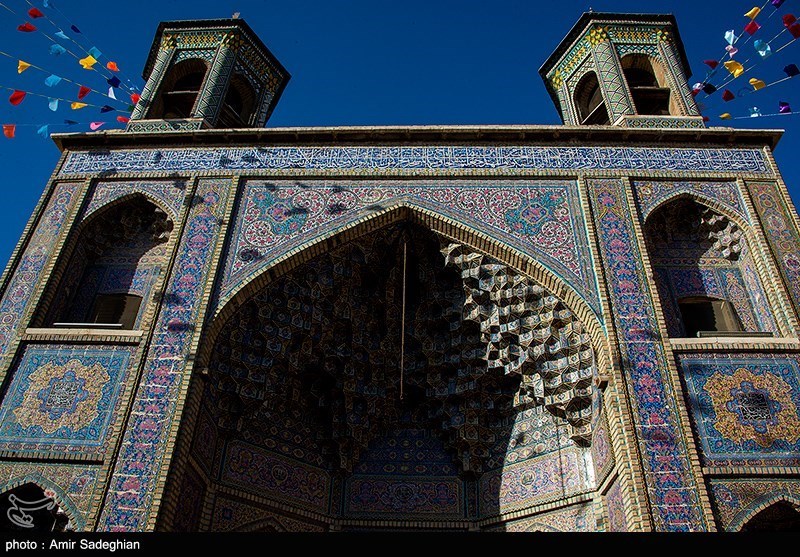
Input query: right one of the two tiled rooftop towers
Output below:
<box><xmin>539</xmin><ymin>12</ymin><xmax>705</xmax><ymax>128</ymax></box>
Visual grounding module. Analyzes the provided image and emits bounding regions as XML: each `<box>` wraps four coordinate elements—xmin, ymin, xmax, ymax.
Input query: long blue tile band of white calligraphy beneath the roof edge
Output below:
<box><xmin>59</xmin><ymin>145</ymin><xmax>772</xmax><ymax>176</ymax></box>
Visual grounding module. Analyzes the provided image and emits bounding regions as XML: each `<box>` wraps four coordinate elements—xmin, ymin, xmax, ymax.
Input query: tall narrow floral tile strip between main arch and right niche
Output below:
<box><xmin>588</xmin><ymin>179</ymin><xmax>707</xmax><ymax>531</ymax></box>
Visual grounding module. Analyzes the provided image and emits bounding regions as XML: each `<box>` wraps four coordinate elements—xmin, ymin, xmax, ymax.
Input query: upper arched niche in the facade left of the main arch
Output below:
<box><xmin>38</xmin><ymin>194</ymin><xmax>173</xmax><ymax>329</ymax></box>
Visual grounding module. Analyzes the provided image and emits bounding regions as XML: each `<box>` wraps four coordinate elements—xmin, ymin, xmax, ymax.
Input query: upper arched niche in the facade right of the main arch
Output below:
<box><xmin>644</xmin><ymin>195</ymin><xmax>779</xmax><ymax>338</ymax></box>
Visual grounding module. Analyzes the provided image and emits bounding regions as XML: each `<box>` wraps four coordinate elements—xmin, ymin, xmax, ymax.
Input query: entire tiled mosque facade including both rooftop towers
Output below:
<box><xmin>0</xmin><ymin>13</ymin><xmax>800</xmax><ymax>532</ymax></box>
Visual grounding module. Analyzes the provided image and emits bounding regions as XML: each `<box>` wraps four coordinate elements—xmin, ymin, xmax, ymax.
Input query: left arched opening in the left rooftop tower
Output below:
<box><xmin>147</xmin><ymin>58</ymin><xmax>208</xmax><ymax>120</ymax></box>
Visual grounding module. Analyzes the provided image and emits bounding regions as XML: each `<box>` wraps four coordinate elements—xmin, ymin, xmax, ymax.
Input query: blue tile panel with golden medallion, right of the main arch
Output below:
<box><xmin>679</xmin><ymin>354</ymin><xmax>800</xmax><ymax>466</ymax></box>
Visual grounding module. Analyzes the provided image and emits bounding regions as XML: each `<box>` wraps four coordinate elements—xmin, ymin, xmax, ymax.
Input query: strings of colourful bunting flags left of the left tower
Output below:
<box><xmin>0</xmin><ymin>0</ymin><xmax>141</xmax><ymax>139</ymax></box>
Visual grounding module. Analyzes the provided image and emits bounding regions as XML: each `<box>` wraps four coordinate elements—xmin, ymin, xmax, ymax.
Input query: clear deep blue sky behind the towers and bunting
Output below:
<box><xmin>0</xmin><ymin>0</ymin><xmax>800</xmax><ymax>265</ymax></box>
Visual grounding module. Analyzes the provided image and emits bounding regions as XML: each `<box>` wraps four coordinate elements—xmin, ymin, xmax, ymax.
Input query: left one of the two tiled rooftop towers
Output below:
<box><xmin>127</xmin><ymin>18</ymin><xmax>290</xmax><ymax>132</ymax></box>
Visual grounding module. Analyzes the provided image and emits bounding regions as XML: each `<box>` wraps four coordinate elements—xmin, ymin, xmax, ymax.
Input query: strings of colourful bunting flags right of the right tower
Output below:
<box><xmin>691</xmin><ymin>0</ymin><xmax>800</xmax><ymax>121</ymax></box>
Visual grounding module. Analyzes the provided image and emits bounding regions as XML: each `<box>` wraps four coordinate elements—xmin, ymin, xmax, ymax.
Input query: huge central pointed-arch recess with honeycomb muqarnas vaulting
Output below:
<box><xmin>160</xmin><ymin>215</ymin><xmax>598</xmax><ymax>531</ymax></box>
